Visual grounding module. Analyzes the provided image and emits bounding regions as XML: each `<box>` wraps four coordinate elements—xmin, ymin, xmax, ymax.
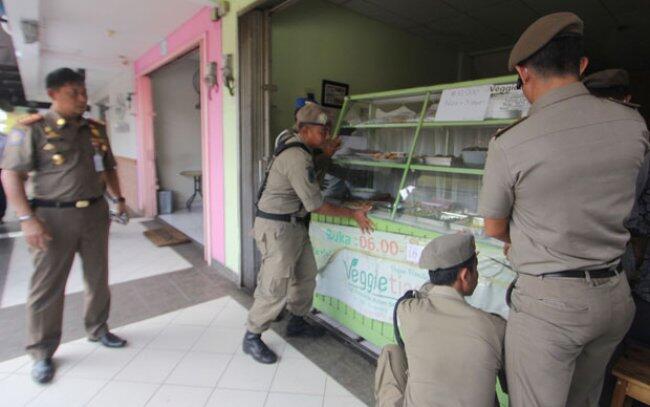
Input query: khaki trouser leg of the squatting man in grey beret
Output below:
<box><xmin>375</xmin><ymin>345</ymin><xmax>408</xmax><ymax>407</ymax></box>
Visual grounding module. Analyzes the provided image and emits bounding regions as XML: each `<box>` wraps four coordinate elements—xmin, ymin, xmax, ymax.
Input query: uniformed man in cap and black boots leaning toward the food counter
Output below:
<box><xmin>243</xmin><ymin>103</ymin><xmax>373</xmax><ymax>363</ymax></box>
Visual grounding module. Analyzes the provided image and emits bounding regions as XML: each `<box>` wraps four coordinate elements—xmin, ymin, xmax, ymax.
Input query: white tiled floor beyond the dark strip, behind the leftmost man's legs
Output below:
<box><xmin>0</xmin><ymin>220</ymin><xmax>192</xmax><ymax>308</ymax></box>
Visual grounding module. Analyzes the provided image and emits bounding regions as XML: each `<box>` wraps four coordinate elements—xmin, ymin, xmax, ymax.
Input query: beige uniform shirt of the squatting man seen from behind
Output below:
<box><xmin>397</xmin><ymin>285</ymin><xmax>505</xmax><ymax>407</ymax></box>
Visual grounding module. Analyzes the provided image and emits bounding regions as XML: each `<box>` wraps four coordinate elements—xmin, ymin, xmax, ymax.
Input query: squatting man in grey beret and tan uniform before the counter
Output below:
<box><xmin>375</xmin><ymin>234</ymin><xmax>506</xmax><ymax>407</ymax></box>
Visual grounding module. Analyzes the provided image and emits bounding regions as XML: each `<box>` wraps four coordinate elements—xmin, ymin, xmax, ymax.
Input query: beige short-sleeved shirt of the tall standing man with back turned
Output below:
<box><xmin>479</xmin><ymin>82</ymin><xmax>648</xmax><ymax>275</ymax></box>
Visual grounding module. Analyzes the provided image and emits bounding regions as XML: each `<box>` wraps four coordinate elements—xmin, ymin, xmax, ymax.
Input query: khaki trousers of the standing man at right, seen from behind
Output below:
<box><xmin>505</xmin><ymin>273</ymin><xmax>634</xmax><ymax>407</ymax></box>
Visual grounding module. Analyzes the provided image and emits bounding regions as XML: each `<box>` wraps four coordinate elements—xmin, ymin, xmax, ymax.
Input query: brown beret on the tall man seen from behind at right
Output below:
<box><xmin>508</xmin><ymin>12</ymin><xmax>584</xmax><ymax>71</ymax></box>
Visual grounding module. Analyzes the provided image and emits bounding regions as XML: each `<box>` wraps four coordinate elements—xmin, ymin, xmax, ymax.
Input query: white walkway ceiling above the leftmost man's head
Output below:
<box><xmin>3</xmin><ymin>0</ymin><xmax>212</xmax><ymax>101</ymax></box>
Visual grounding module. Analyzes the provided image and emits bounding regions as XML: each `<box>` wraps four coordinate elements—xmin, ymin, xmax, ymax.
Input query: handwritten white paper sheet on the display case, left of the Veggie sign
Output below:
<box><xmin>435</xmin><ymin>85</ymin><xmax>490</xmax><ymax>121</ymax></box>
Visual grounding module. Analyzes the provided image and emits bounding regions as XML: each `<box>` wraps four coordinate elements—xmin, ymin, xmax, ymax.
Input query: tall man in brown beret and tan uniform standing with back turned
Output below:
<box><xmin>479</xmin><ymin>13</ymin><xmax>648</xmax><ymax>407</ymax></box>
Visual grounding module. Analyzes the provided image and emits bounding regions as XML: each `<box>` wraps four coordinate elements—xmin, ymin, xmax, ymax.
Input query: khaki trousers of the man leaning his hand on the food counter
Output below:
<box><xmin>247</xmin><ymin>218</ymin><xmax>318</xmax><ymax>334</ymax></box>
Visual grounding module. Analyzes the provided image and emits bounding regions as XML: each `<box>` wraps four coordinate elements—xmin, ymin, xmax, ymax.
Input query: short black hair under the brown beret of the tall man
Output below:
<box><xmin>518</xmin><ymin>35</ymin><xmax>585</xmax><ymax>77</ymax></box>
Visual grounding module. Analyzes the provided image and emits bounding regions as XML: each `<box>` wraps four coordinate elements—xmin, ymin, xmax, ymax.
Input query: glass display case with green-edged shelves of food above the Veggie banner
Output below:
<box><xmin>325</xmin><ymin>76</ymin><xmax>528</xmax><ymax>238</ymax></box>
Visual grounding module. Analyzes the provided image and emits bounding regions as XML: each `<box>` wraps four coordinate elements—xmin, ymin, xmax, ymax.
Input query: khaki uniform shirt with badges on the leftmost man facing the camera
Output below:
<box><xmin>0</xmin><ymin>111</ymin><xmax>116</xmax><ymax>202</ymax></box>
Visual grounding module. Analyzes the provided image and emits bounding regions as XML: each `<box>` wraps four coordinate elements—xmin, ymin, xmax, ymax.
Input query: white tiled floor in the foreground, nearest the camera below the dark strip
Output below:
<box><xmin>0</xmin><ymin>297</ymin><xmax>364</xmax><ymax>407</ymax></box>
